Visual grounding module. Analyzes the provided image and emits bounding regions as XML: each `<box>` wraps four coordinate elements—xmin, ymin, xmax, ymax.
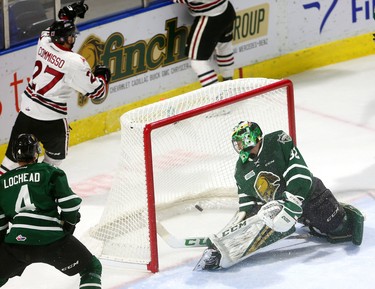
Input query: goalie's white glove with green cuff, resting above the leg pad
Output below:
<box><xmin>257</xmin><ymin>192</ymin><xmax>302</xmax><ymax>232</ymax></box>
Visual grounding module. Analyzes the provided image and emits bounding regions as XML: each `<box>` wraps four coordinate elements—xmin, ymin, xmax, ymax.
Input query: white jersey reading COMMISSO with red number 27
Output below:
<box><xmin>21</xmin><ymin>31</ymin><xmax>107</xmax><ymax>120</ymax></box>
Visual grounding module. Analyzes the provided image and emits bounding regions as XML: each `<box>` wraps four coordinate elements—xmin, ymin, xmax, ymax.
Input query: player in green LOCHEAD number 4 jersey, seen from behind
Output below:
<box><xmin>0</xmin><ymin>134</ymin><xmax>102</xmax><ymax>289</ymax></box>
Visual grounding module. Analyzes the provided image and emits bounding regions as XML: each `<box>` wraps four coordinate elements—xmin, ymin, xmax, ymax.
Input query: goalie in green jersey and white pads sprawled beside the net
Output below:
<box><xmin>195</xmin><ymin>121</ymin><xmax>364</xmax><ymax>270</ymax></box>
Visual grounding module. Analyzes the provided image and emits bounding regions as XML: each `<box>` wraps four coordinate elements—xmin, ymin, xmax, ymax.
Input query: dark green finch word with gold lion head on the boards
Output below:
<box><xmin>78</xmin><ymin>17</ymin><xmax>189</xmax><ymax>106</ymax></box>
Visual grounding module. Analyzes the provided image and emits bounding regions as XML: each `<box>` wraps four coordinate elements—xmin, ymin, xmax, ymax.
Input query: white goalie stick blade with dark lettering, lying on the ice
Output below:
<box><xmin>156</xmin><ymin>221</ymin><xmax>208</xmax><ymax>248</ymax></box>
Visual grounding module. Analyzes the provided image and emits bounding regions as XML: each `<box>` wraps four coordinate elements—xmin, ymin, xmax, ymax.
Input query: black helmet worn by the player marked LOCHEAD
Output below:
<box><xmin>13</xmin><ymin>133</ymin><xmax>41</xmax><ymax>162</ymax></box>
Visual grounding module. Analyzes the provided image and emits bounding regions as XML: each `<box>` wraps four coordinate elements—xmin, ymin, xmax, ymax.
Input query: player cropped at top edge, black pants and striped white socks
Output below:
<box><xmin>173</xmin><ymin>0</ymin><xmax>236</xmax><ymax>86</ymax></box>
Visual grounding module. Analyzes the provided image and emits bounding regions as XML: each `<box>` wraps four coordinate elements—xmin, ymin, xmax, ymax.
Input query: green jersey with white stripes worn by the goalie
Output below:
<box><xmin>235</xmin><ymin>130</ymin><xmax>313</xmax><ymax>213</ymax></box>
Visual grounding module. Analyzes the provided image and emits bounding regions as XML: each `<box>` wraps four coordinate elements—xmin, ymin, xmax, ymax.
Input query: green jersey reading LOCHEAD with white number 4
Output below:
<box><xmin>0</xmin><ymin>163</ymin><xmax>82</xmax><ymax>245</ymax></box>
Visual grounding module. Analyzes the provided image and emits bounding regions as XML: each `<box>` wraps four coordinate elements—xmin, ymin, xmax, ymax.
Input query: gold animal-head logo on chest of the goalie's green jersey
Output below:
<box><xmin>254</xmin><ymin>171</ymin><xmax>280</xmax><ymax>202</ymax></box>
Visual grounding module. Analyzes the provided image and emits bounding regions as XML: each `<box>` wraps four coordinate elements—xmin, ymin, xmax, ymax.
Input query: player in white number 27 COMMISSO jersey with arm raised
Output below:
<box><xmin>0</xmin><ymin>3</ymin><xmax>111</xmax><ymax>175</ymax></box>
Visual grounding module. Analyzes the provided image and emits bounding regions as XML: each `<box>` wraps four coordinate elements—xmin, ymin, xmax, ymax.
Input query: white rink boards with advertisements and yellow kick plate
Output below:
<box><xmin>0</xmin><ymin>0</ymin><xmax>375</xmax><ymax>158</ymax></box>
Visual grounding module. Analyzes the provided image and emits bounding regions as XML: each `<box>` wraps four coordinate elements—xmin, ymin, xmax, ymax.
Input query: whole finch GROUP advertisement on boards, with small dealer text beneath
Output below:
<box><xmin>74</xmin><ymin>10</ymin><xmax>270</xmax><ymax>106</ymax></box>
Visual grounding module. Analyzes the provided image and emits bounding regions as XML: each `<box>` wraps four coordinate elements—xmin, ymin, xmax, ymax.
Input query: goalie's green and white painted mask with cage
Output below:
<box><xmin>232</xmin><ymin>121</ymin><xmax>263</xmax><ymax>163</ymax></box>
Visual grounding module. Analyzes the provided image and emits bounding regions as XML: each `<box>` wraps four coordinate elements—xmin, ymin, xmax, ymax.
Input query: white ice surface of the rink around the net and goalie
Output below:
<box><xmin>0</xmin><ymin>56</ymin><xmax>375</xmax><ymax>289</ymax></box>
